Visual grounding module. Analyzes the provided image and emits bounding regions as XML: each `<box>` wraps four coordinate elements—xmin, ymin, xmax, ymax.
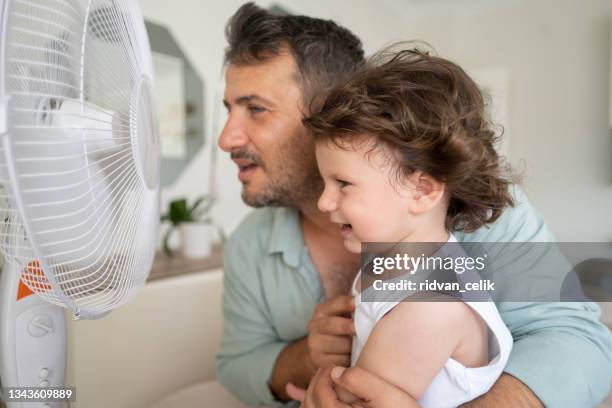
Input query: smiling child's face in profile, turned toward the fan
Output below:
<box><xmin>316</xmin><ymin>141</ymin><xmax>414</xmax><ymax>253</ymax></box>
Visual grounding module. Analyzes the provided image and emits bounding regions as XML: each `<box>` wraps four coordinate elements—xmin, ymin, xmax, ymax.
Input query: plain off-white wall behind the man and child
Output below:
<box><xmin>141</xmin><ymin>0</ymin><xmax>612</xmax><ymax>241</ymax></box>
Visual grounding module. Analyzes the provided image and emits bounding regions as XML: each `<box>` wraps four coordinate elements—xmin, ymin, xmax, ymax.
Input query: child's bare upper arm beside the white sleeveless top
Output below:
<box><xmin>356</xmin><ymin>298</ymin><xmax>486</xmax><ymax>400</ymax></box>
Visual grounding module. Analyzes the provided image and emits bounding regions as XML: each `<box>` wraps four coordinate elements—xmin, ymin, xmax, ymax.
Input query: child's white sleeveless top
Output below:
<box><xmin>351</xmin><ymin>235</ymin><xmax>512</xmax><ymax>408</ymax></box>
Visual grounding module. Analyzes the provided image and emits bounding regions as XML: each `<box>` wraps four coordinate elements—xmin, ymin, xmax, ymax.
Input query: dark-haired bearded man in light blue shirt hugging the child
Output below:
<box><xmin>217</xmin><ymin>4</ymin><xmax>612</xmax><ymax>407</ymax></box>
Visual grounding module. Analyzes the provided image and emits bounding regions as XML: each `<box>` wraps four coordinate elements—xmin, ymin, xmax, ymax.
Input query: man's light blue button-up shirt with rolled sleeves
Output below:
<box><xmin>217</xmin><ymin>190</ymin><xmax>612</xmax><ymax>408</ymax></box>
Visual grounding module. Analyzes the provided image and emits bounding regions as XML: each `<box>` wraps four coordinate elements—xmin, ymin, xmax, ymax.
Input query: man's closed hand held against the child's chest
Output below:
<box><xmin>307</xmin><ymin>295</ymin><xmax>355</xmax><ymax>368</ymax></box>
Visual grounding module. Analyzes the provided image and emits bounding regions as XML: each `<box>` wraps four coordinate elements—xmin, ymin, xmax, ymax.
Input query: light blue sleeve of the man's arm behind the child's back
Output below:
<box><xmin>456</xmin><ymin>188</ymin><xmax>612</xmax><ymax>407</ymax></box>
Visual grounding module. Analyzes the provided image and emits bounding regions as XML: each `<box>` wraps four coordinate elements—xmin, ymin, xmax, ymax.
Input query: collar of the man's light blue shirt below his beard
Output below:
<box><xmin>268</xmin><ymin>207</ymin><xmax>304</xmax><ymax>268</ymax></box>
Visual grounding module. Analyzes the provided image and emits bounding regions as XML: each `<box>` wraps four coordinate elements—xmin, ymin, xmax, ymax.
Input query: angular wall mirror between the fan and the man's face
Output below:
<box><xmin>145</xmin><ymin>21</ymin><xmax>205</xmax><ymax>186</ymax></box>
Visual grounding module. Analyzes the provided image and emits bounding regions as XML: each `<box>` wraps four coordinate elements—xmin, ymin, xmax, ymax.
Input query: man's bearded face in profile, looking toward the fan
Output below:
<box><xmin>219</xmin><ymin>53</ymin><xmax>322</xmax><ymax>207</ymax></box>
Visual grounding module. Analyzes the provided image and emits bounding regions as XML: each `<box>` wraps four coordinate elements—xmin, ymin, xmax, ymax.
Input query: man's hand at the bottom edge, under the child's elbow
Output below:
<box><xmin>302</xmin><ymin>367</ymin><xmax>419</xmax><ymax>408</ymax></box>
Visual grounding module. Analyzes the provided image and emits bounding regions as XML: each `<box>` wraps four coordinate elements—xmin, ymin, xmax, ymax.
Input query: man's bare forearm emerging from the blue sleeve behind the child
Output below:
<box><xmin>461</xmin><ymin>373</ymin><xmax>544</xmax><ymax>408</ymax></box>
